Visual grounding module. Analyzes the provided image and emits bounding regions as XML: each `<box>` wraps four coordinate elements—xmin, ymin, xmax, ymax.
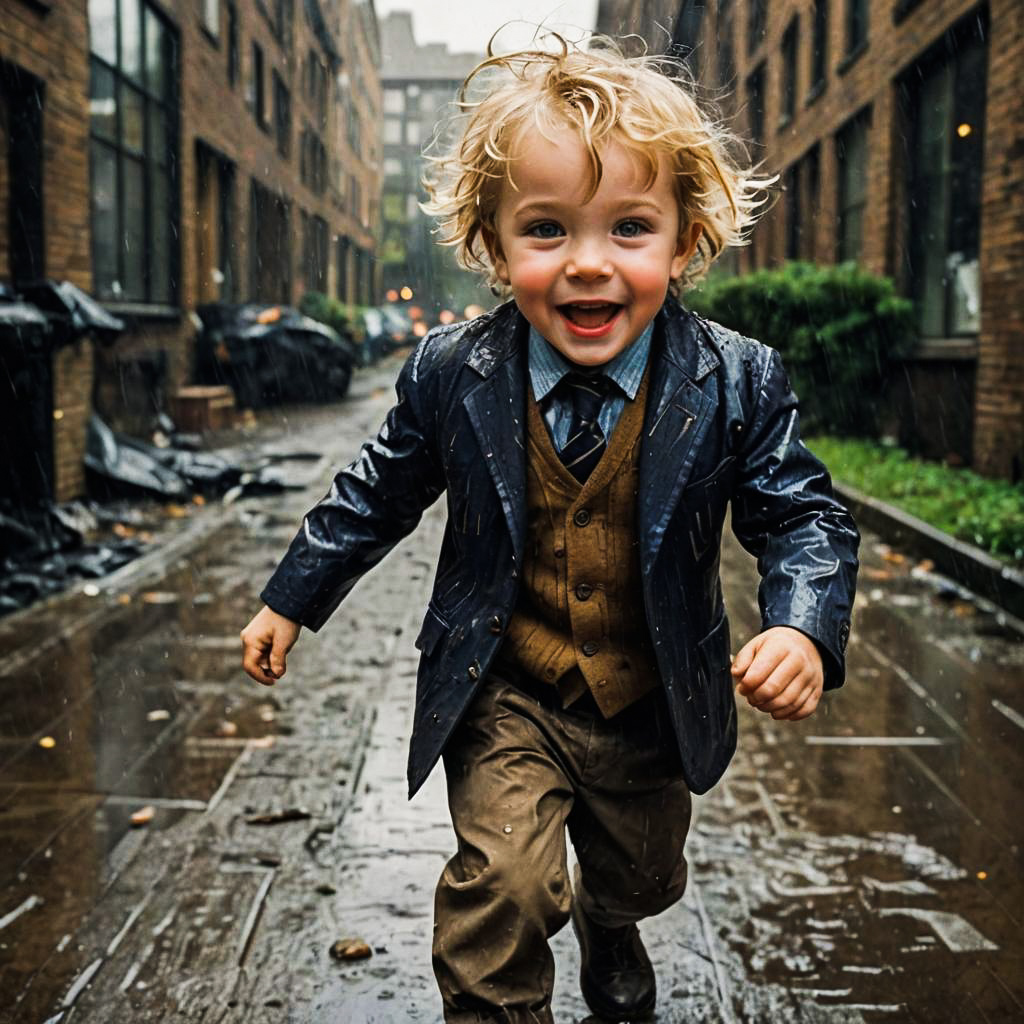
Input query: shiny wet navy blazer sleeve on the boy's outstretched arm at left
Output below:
<box><xmin>260</xmin><ymin>337</ymin><xmax>444</xmax><ymax>631</ymax></box>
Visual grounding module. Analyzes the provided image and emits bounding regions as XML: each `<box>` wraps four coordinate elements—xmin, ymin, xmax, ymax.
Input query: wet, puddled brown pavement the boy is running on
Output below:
<box><xmin>0</xmin><ymin>356</ymin><xmax>1024</xmax><ymax>1024</ymax></box>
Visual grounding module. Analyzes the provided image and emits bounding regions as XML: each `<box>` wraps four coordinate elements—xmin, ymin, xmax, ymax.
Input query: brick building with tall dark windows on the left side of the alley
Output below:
<box><xmin>0</xmin><ymin>0</ymin><xmax>380</xmax><ymax>500</ymax></box>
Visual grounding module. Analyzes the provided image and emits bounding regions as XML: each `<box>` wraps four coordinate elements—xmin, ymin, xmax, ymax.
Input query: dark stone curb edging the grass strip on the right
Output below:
<box><xmin>833</xmin><ymin>482</ymin><xmax>1024</xmax><ymax>618</ymax></box>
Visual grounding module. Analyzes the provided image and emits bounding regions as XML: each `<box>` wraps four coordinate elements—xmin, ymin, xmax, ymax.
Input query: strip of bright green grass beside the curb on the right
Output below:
<box><xmin>807</xmin><ymin>437</ymin><xmax>1024</xmax><ymax>562</ymax></box>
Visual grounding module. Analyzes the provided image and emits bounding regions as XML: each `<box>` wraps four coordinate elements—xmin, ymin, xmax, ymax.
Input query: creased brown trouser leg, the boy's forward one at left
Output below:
<box><xmin>433</xmin><ymin>681</ymin><xmax>572</xmax><ymax>1024</ymax></box>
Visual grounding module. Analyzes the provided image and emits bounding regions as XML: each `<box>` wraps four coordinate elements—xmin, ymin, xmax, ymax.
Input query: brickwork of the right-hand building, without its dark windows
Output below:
<box><xmin>598</xmin><ymin>0</ymin><xmax>1024</xmax><ymax>478</ymax></box>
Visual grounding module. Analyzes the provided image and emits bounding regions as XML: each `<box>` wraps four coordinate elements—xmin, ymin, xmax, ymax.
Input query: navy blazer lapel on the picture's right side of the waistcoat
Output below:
<box><xmin>638</xmin><ymin>303</ymin><xmax>718</xmax><ymax>574</ymax></box>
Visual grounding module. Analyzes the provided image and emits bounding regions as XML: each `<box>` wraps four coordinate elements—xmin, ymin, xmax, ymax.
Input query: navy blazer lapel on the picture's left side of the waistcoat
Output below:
<box><xmin>463</xmin><ymin>311</ymin><xmax>526</xmax><ymax>562</ymax></box>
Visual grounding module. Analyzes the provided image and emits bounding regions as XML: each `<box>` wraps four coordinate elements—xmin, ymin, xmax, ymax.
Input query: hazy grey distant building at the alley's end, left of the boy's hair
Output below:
<box><xmin>380</xmin><ymin>11</ymin><xmax>493</xmax><ymax>315</ymax></box>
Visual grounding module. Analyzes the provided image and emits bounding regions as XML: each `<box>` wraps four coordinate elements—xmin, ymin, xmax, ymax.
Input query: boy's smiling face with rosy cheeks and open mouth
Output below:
<box><xmin>493</xmin><ymin>130</ymin><xmax>700</xmax><ymax>367</ymax></box>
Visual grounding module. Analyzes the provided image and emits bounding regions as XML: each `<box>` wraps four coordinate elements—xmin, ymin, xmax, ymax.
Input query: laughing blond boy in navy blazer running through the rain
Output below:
<box><xmin>242</xmin><ymin>36</ymin><xmax>858</xmax><ymax>1024</ymax></box>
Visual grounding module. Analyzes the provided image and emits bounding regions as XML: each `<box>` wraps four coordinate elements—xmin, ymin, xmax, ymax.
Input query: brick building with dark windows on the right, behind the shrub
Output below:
<box><xmin>598</xmin><ymin>0</ymin><xmax>1024</xmax><ymax>479</ymax></box>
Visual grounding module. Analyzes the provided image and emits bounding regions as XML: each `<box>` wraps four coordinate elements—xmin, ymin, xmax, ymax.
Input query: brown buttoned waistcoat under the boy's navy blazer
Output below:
<box><xmin>501</xmin><ymin>374</ymin><xmax>658</xmax><ymax>718</ymax></box>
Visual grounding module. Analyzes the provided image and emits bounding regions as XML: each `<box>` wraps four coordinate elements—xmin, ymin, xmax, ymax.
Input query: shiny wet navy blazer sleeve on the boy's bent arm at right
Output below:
<box><xmin>732</xmin><ymin>349</ymin><xmax>860</xmax><ymax>689</ymax></box>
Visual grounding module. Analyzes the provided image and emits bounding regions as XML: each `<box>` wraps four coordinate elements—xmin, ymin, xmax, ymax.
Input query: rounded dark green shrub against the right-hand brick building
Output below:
<box><xmin>687</xmin><ymin>263</ymin><xmax>916</xmax><ymax>437</ymax></box>
